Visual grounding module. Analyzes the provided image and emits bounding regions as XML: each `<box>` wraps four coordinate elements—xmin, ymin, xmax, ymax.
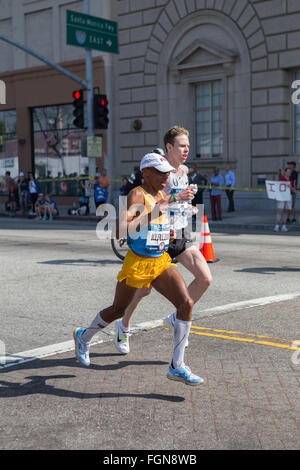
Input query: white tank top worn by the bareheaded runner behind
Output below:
<box><xmin>164</xmin><ymin>165</ymin><xmax>189</xmax><ymax>230</ymax></box>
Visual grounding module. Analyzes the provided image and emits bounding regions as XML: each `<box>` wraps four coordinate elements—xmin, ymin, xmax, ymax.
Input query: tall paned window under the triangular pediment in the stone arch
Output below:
<box><xmin>195</xmin><ymin>80</ymin><xmax>223</xmax><ymax>158</ymax></box>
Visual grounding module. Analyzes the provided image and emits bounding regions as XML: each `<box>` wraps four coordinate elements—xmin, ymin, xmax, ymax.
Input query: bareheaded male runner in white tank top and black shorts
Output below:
<box><xmin>115</xmin><ymin>126</ymin><xmax>212</xmax><ymax>354</ymax></box>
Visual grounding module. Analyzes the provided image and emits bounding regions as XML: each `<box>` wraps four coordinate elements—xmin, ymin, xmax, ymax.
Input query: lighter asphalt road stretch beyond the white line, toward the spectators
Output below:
<box><xmin>0</xmin><ymin>219</ymin><xmax>300</xmax><ymax>354</ymax></box>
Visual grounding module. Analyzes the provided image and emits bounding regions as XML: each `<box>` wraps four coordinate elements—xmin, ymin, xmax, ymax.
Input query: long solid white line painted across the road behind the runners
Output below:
<box><xmin>0</xmin><ymin>292</ymin><xmax>300</xmax><ymax>369</ymax></box>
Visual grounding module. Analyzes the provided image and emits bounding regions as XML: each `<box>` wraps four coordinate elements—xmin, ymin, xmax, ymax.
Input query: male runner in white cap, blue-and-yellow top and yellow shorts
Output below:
<box><xmin>73</xmin><ymin>153</ymin><xmax>203</xmax><ymax>385</ymax></box>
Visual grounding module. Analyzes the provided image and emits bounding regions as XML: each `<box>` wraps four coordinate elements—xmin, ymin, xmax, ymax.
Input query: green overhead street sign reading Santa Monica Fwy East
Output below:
<box><xmin>67</xmin><ymin>10</ymin><xmax>119</xmax><ymax>54</ymax></box>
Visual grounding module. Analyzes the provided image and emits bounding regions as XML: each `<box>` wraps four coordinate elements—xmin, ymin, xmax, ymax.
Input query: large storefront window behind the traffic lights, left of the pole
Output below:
<box><xmin>32</xmin><ymin>104</ymin><xmax>88</xmax><ymax>195</ymax></box>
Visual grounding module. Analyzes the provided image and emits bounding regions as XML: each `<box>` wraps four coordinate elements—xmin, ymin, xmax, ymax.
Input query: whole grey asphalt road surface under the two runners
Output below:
<box><xmin>0</xmin><ymin>219</ymin><xmax>300</xmax><ymax>452</ymax></box>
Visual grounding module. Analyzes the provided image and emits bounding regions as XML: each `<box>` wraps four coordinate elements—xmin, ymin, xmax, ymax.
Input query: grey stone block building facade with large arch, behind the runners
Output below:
<box><xmin>112</xmin><ymin>0</ymin><xmax>300</xmax><ymax>187</ymax></box>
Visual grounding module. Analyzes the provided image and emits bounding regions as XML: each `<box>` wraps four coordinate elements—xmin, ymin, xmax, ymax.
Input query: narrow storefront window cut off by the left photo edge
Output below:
<box><xmin>0</xmin><ymin>109</ymin><xmax>19</xmax><ymax>190</ymax></box>
